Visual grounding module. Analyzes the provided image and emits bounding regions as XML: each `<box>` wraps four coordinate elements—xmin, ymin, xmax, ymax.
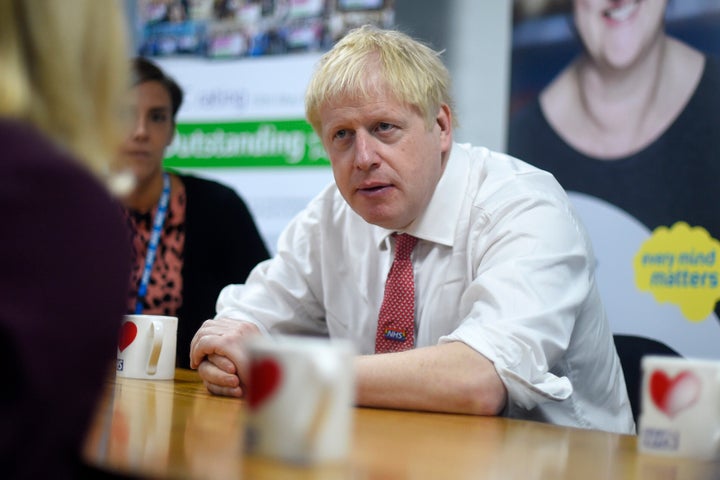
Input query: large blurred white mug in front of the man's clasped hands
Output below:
<box><xmin>245</xmin><ymin>336</ymin><xmax>355</xmax><ymax>464</ymax></box>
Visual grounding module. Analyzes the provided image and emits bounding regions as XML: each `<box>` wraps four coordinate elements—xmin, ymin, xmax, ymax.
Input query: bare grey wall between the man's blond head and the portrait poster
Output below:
<box><xmin>396</xmin><ymin>0</ymin><xmax>512</xmax><ymax>150</ymax></box>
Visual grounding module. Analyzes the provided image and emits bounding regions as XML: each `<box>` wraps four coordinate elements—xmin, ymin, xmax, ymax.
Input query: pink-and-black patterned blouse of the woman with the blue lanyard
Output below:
<box><xmin>125</xmin><ymin>178</ymin><xmax>187</xmax><ymax>316</ymax></box>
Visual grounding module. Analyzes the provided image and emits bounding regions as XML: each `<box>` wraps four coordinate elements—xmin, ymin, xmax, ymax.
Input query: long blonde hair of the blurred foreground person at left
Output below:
<box><xmin>0</xmin><ymin>0</ymin><xmax>130</xmax><ymax>186</ymax></box>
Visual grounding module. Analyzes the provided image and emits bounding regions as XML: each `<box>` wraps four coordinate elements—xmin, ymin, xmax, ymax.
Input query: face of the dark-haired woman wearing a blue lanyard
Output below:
<box><xmin>120</xmin><ymin>81</ymin><xmax>175</xmax><ymax>185</ymax></box>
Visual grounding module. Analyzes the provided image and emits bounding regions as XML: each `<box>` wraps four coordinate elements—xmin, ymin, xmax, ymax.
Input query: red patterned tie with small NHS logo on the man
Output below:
<box><xmin>375</xmin><ymin>233</ymin><xmax>417</xmax><ymax>353</ymax></box>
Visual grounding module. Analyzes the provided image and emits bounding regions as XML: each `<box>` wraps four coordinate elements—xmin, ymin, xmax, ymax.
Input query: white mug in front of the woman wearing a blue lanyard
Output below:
<box><xmin>116</xmin><ymin>315</ymin><xmax>178</xmax><ymax>380</ymax></box>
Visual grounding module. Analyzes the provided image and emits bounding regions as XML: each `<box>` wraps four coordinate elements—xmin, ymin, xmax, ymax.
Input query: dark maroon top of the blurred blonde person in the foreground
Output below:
<box><xmin>0</xmin><ymin>120</ymin><xmax>130</xmax><ymax>479</ymax></box>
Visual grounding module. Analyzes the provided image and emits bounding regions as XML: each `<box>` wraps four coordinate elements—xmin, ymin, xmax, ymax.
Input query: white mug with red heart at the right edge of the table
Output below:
<box><xmin>638</xmin><ymin>356</ymin><xmax>720</xmax><ymax>460</ymax></box>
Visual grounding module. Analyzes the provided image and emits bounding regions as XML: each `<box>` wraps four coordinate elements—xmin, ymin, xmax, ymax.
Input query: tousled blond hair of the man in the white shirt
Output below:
<box><xmin>305</xmin><ymin>25</ymin><xmax>454</xmax><ymax>133</ymax></box>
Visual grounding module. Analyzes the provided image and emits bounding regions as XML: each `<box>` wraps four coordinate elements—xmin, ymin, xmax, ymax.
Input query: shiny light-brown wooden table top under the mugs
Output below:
<box><xmin>83</xmin><ymin>369</ymin><xmax>720</xmax><ymax>480</ymax></box>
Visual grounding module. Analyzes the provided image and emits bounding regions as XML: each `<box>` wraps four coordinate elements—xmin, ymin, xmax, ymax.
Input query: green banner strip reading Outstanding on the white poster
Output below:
<box><xmin>164</xmin><ymin>120</ymin><xmax>330</xmax><ymax>168</ymax></box>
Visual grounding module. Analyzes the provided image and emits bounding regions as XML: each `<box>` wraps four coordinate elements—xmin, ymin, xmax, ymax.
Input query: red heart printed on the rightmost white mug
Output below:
<box><xmin>650</xmin><ymin>370</ymin><xmax>702</xmax><ymax>418</ymax></box>
